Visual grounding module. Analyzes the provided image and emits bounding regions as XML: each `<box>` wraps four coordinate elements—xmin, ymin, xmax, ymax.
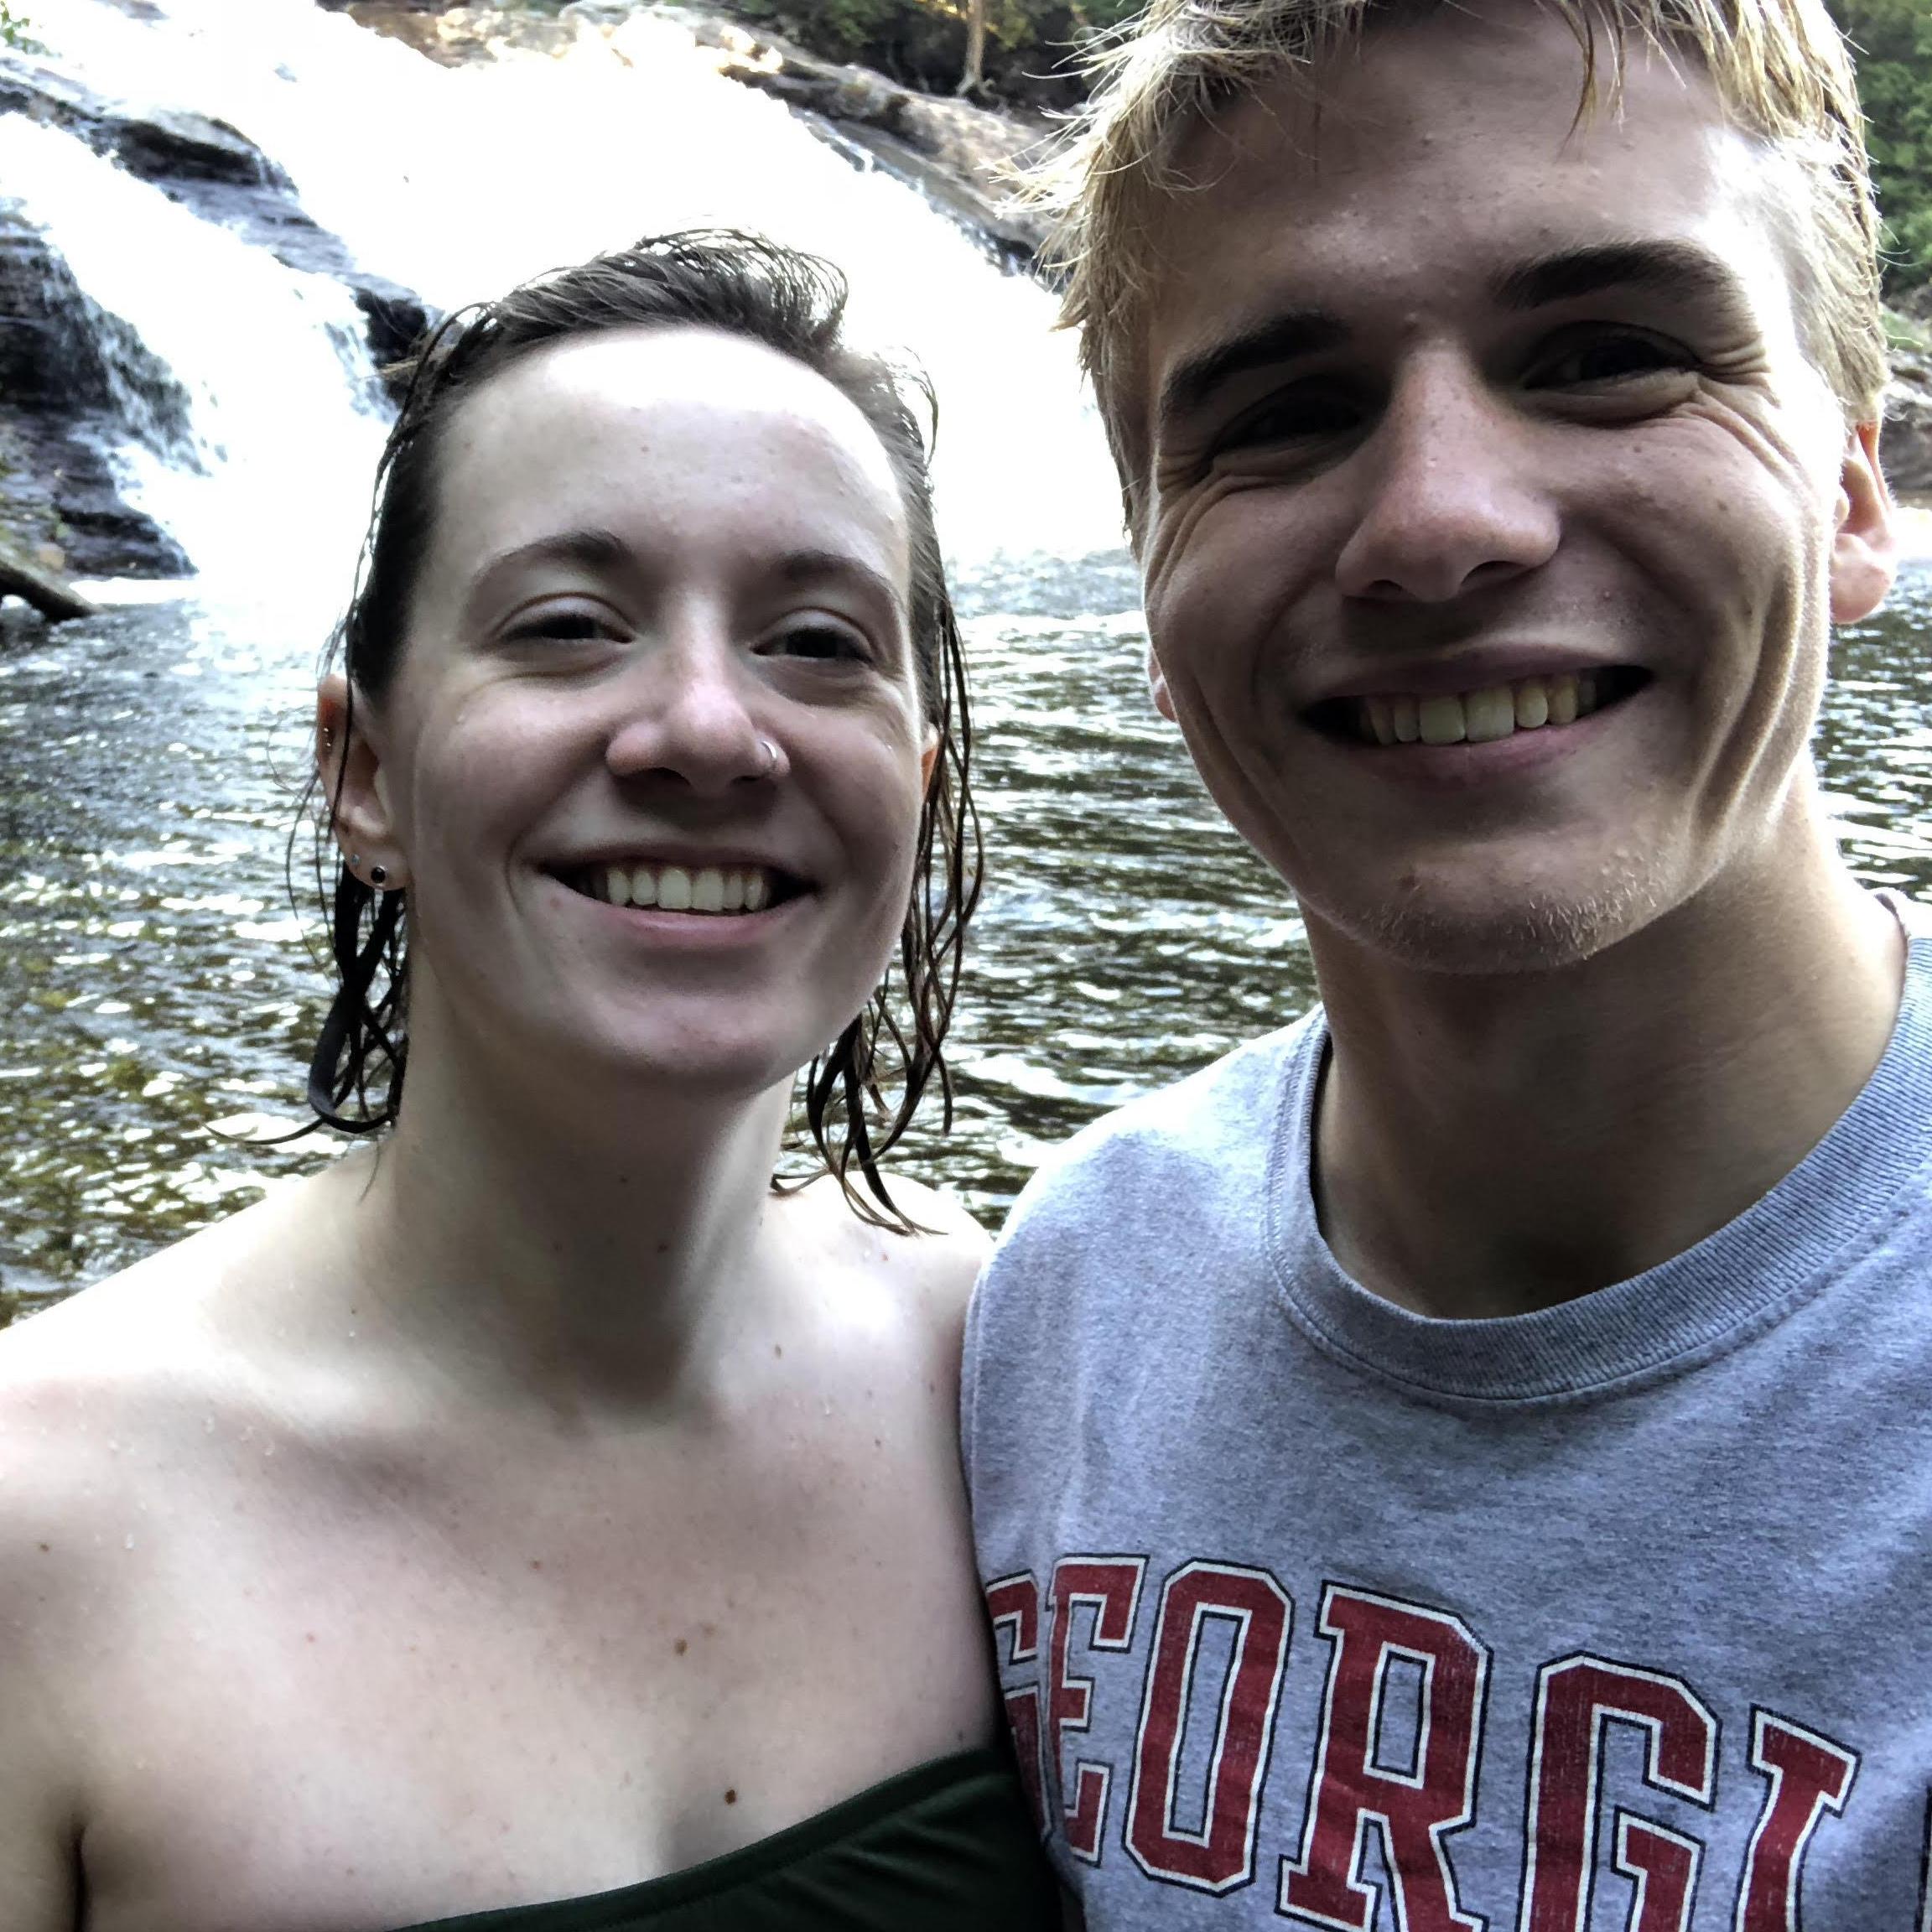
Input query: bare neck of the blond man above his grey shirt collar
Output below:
<box><xmin>1310</xmin><ymin>808</ymin><xmax>1903</xmax><ymax>1317</ymax></box>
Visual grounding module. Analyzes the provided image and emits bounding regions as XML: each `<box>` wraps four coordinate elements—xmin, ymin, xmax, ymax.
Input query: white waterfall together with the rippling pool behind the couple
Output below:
<box><xmin>0</xmin><ymin>0</ymin><xmax>1932</xmax><ymax>1322</ymax></box>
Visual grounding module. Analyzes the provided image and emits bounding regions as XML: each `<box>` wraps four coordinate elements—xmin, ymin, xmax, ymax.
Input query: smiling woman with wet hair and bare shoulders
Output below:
<box><xmin>0</xmin><ymin>234</ymin><xmax>1057</xmax><ymax>1932</ymax></box>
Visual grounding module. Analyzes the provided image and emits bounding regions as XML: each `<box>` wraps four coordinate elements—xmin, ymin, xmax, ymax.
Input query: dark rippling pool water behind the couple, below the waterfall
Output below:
<box><xmin>0</xmin><ymin>572</ymin><xmax>1932</xmax><ymax>1317</ymax></box>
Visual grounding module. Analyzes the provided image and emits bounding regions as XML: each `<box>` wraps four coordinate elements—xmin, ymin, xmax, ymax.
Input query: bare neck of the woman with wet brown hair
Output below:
<box><xmin>335</xmin><ymin>1016</ymin><xmax>790</xmax><ymax>1410</ymax></box>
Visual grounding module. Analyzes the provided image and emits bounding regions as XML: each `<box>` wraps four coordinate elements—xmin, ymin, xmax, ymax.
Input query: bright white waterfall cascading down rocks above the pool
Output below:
<box><xmin>11</xmin><ymin>0</ymin><xmax>1120</xmax><ymax>587</ymax></box>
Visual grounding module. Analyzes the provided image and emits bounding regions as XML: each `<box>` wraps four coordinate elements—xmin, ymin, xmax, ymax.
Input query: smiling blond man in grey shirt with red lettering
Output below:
<box><xmin>964</xmin><ymin>0</ymin><xmax>1932</xmax><ymax>1932</ymax></box>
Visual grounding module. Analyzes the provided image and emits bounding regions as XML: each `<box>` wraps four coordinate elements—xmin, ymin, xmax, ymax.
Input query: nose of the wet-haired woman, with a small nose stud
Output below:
<box><xmin>605</xmin><ymin>610</ymin><xmax>784</xmax><ymax>798</ymax></box>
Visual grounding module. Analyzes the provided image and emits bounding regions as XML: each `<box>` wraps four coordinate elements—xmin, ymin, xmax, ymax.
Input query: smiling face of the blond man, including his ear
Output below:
<box><xmin>1120</xmin><ymin>0</ymin><xmax>1889</xmax><ymax>970</ymax></box>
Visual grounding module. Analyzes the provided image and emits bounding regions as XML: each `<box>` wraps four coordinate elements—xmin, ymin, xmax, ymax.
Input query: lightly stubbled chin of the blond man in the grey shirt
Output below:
<box><xmin>1302</xmin><ymin>875</ymin><xmax>1661</xmax><ymax>976</ymax></box>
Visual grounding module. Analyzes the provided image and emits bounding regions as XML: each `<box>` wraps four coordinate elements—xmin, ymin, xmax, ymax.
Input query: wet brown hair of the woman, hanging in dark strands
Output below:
<box><xmin>309</xmin><ymin>228</ymin><xmax>979</xmax><ymax>1233</ymax></box>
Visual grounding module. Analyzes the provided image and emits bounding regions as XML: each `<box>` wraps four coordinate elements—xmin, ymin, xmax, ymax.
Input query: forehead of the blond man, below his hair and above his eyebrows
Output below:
<box><xmin>1136</xmin><ymin>8</ymin><xmax>1789</xmax><ymax>418</ymax></box>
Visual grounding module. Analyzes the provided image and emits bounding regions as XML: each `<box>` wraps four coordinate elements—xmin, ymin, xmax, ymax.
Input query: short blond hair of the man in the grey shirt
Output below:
<box><xmin>1026</xmin><ymin>0</ymin><xmax>1888</xmax><ymax>506</ymax></box>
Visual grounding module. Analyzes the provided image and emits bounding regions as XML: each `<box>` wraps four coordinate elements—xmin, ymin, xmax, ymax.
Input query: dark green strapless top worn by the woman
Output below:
<box><xmin>386</xmin><ymin>1750</ymin><xmax>1061</xmax><ymax>1932</ymax></box>
